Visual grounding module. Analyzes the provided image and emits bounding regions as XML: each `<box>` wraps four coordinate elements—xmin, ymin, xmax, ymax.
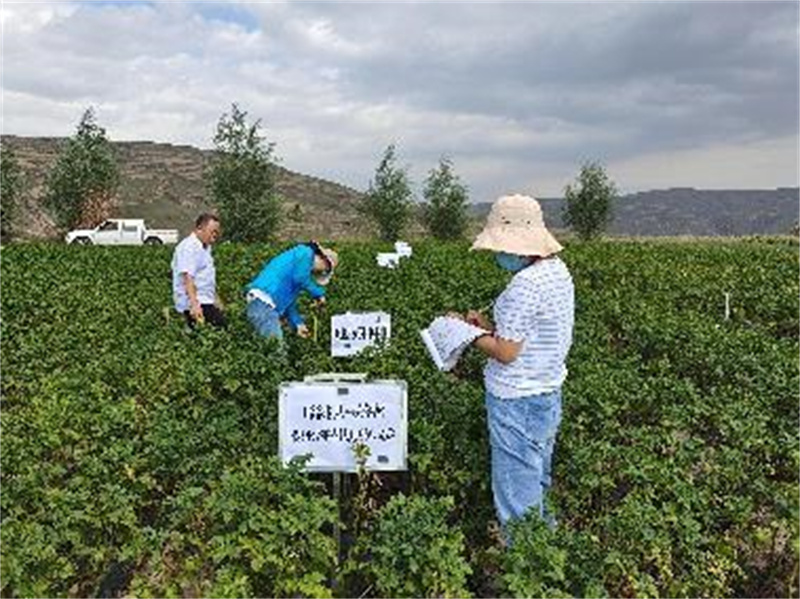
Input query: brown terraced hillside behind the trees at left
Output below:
<box><xmin>0</xmin><ymin>135</ymin><xmax>368</xmax><ymax>239</ymax></box>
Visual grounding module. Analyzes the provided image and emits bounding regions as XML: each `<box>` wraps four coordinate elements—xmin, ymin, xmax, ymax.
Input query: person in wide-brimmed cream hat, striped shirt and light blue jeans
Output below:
<box><xmin>454</xmin><ymin>195</ymin><xmax>575</xmax><ymax>540</ymax></box>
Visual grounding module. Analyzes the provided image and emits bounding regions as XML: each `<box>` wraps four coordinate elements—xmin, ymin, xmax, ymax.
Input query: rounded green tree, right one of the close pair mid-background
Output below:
<box><xmin>422</xmin><ymin>157</ymin><xmax>467</xmax><ymax>239</ymax></box>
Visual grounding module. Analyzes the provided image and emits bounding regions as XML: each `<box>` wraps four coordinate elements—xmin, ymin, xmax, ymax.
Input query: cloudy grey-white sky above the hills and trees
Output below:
<box><xmin>0</xmin><ymin>0</ymin><xmax>800</xmax><ymax>201</ymax></box>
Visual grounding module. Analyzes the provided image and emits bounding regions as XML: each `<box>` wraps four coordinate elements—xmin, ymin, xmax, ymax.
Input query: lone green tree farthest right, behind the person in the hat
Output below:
<box><xmin>564</xmin><ymin>162</ymin><xmax>617</xmax><ymax>240</ymax></box>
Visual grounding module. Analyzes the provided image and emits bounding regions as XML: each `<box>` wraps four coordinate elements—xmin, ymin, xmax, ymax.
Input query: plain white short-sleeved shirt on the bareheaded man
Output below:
<box><xmin>172</xmin><ymin>233</ymin><xmax>217</xmax><ymax>312</ymax></box>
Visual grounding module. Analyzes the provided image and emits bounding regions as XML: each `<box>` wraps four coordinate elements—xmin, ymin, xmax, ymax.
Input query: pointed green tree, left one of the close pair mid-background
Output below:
<box><xmin>359</xmin><ymin>144</ymin><xmax>411</xmax><ymax>241</ymax></box>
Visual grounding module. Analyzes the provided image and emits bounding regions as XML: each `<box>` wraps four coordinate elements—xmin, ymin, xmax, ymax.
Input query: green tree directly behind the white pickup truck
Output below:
<box><xmin>44</xmin><ymin>108</ymin><xmax>119</xmax><ymax>229</ymax></box>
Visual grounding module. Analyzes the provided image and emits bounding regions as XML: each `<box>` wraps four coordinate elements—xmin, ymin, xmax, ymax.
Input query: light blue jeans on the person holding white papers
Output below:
<box><xmin>486</xmin><ymin>389</ymin><xmax>561</xmax><ymax>528</ymax></box>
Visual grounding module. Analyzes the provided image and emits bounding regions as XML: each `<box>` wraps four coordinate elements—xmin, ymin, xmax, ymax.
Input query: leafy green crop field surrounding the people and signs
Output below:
<box><xmin>0</xmin><ymin>240</ymin><xmax>800</xmax><ymax>597</ymax></box>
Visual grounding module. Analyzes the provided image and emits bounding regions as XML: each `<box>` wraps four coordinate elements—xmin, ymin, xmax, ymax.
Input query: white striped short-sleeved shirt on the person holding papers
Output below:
<box><xmin>484</xmin><ymin>257</ymin><xmax>575</xmax><ymax>398</ymax></box>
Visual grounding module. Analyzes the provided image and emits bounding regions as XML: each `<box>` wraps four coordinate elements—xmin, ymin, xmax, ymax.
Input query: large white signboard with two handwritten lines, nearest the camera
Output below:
<box><xmin>278</xmin><ymin>381</ymin><xmax>408</xmax><ymax>472</ymax></box>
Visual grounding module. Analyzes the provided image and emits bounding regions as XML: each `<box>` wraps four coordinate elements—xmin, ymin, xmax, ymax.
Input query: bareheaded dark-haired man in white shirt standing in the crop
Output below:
<box><xmin>172</xmin><ymin>213</ymin><xmax>226</xmax><ymax>328</ymax></box>
